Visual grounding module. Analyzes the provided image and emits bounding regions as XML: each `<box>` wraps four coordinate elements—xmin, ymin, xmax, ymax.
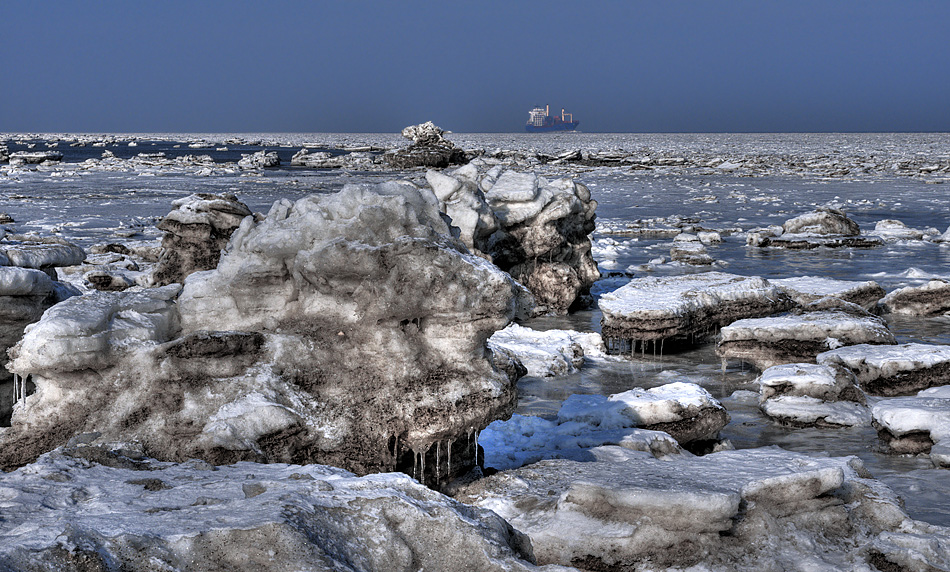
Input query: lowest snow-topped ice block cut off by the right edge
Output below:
<box><xmin>871</xmin><ymin>386</ymin><xmax>950</xmax><ymax>468</ymax></box>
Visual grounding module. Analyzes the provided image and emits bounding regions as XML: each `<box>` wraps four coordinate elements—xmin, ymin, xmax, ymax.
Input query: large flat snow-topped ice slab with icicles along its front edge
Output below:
<box><xmin>599</xmin><ymin>272</ymin><xmax>792</xmax><ymax>353</ymax></box>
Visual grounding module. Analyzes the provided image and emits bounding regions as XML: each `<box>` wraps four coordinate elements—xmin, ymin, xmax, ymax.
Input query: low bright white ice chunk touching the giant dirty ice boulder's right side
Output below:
<box><xmin>488</xmin><ymin>324</ymin><xmax>604</xmax><ymax>377</ymax></box>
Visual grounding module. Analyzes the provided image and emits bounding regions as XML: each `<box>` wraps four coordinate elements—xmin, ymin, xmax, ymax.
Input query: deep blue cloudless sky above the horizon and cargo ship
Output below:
<box><xmin>0</xmin><ymin>0</ymin><xmax>950</xmax><ymax>132</ymax></box>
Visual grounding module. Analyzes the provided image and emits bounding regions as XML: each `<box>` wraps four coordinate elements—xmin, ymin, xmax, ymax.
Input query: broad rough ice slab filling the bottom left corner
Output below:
<box><xmin>0</xmin><ymin>442</ymin><xmax>552</xmax><ymax>572</ymax></box>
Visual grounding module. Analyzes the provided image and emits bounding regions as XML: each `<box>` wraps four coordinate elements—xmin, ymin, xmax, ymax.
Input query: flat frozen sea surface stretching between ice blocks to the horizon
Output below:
<box><xmin>0</xmin><ymin>133</ymin><xmax>950</xmax><ymax>525</ymax></box>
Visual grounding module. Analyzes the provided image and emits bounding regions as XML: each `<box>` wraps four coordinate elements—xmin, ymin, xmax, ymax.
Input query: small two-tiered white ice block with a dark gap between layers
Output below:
<box><xmin>756</xmin><ymin>363</ymin><xmax>871</xmax><ymax>427</ymax></box>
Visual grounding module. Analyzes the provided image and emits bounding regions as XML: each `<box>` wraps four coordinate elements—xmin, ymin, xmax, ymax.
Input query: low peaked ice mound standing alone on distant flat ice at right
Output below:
<box><xmin>746</xmin><ymin>207</ymin><xmax>884</xmax><ymax>250</ymax></box>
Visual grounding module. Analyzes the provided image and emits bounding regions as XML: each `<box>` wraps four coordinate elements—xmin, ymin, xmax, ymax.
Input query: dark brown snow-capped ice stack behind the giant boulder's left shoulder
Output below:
<box><xmin>152</xmin><ymin>193</ymin><xmax>251</xmax><ymax>286</ymax></box>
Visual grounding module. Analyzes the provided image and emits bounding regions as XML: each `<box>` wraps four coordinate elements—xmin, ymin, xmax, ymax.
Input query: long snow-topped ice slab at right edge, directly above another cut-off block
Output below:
<box><xmin>817</xmin><ymin>343</ymin><xmax>950</xmax><ymax>397</ymax></box>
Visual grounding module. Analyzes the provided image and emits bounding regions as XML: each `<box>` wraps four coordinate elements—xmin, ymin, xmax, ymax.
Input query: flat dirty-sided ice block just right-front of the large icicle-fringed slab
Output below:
<box><xmin>716</xmin><ymin>310</ymin><xmax>897</xmax><ymax>371</ymax></box>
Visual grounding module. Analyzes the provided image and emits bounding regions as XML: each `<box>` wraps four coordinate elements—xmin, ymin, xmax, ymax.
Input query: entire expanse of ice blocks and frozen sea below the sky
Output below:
<box><xmin>0</xmin><ymin>132</ymin><xmax>950</xmax><ymax>572</ymax></box>
